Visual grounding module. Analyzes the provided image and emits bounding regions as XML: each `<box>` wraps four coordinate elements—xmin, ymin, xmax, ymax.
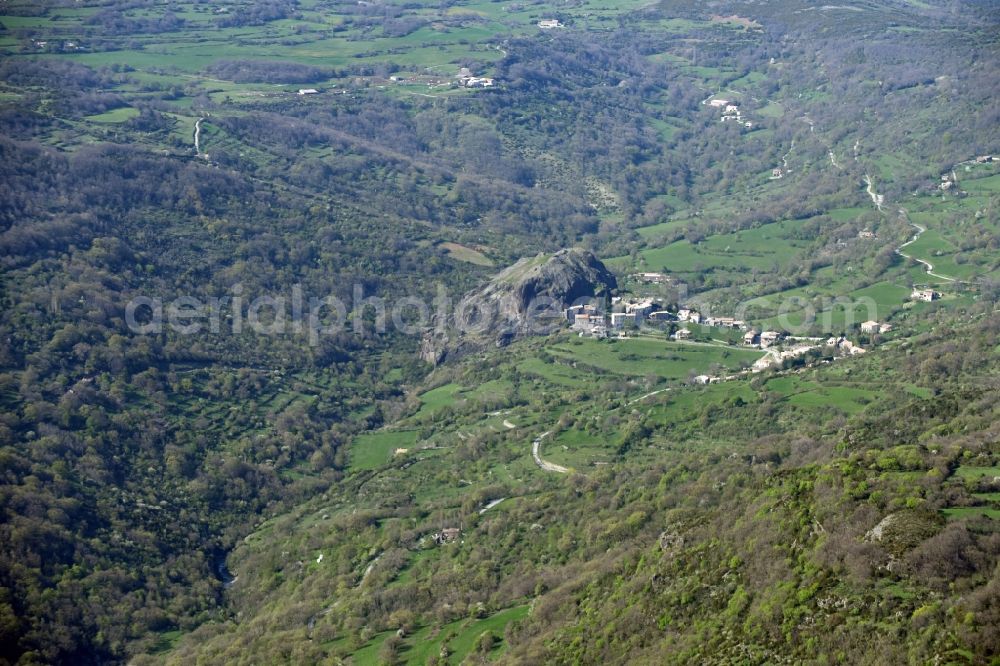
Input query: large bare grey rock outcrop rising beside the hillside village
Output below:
<box><xmin>420</xmin><ymin>248</ymin><xmax>617</xmax><ymax>363</ymax></box>
